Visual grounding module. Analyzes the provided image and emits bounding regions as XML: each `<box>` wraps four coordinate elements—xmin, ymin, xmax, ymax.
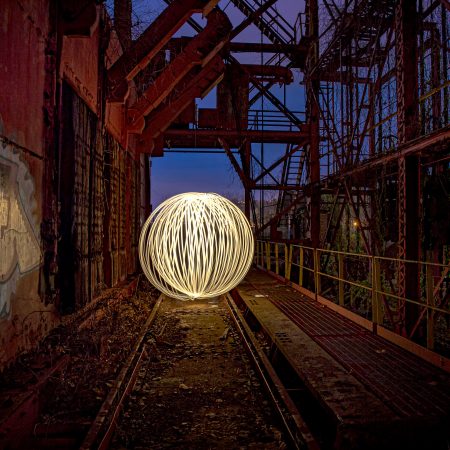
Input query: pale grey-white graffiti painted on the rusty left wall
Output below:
<box><xmin>0</xmin><ymin>145</ymin><xmax>41</xmax><ymax>320</ymax></box>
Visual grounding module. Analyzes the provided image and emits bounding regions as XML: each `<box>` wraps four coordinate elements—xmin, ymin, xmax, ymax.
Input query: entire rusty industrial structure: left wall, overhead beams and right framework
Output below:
<box><xmin>0</xmin><ymin>0</ymin><xmax>450</xmax><ymax>367</ymax></box>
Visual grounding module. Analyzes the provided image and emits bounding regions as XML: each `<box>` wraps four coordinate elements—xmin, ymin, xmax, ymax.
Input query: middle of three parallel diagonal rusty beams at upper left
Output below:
<box><xmin>128</xmin><ymin>10</ymin><xmax>232</xmax><ymax>133</ymax></box>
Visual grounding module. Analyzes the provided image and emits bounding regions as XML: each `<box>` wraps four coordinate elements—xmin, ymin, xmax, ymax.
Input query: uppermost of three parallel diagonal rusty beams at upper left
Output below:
<box><xmin>108</xmin><ymin>0</ymin><xmax>218</xmax><ymax>103</ymax></box>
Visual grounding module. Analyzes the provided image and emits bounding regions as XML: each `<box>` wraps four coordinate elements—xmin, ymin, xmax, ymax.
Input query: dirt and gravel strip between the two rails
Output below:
<box><xmin>111</xmin><ymin>299</ymin><xmax>286</xmax><ymax>449</ymax></box>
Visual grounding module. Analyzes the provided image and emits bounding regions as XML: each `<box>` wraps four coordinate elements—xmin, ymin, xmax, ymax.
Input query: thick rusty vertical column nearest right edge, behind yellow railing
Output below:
<box><xmin>395</xmin><ymin>0</ymin><xmax>420</xmax><ymax>334</ymax></box>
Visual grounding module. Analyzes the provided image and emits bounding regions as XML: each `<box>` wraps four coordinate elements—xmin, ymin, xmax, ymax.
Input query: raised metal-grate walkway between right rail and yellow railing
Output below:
<box><xmin>235</xmin><ymin>270</ymin><xmax>450</xmax><ymax>449</ymax></box>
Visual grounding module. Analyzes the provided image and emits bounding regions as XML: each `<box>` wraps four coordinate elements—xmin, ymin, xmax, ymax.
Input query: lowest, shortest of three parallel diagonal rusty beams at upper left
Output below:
<box><xmin>137</xmin><ymin>55</ymin><xmax>225</xmax><ymax>153</ymax></box>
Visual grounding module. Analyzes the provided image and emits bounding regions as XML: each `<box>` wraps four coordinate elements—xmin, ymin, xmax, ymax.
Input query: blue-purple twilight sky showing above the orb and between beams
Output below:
<box><xmin>106</xmin><ymin>0</ymin><xmax>304</xmax><ymax>207</ymax></box>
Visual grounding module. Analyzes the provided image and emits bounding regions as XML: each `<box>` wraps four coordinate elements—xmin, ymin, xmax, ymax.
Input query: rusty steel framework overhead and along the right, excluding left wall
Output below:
<box><xmin>108</xmin><ymin>0</ymin><xmax>450</xmax><ymax>348</ymax></box>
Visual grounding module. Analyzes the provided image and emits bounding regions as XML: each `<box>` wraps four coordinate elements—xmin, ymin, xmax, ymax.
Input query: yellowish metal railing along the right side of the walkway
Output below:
<box><xmin>255</xmin><ymin>240</ymin><xmax>450</xmax><ymax>353</ymax></box>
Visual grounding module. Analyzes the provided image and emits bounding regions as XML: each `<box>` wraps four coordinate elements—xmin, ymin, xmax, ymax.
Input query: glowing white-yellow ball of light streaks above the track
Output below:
<box><xmin>139</xmin><ymin>192</ymin><xmax>254</xmax><ymax>300</ymax></box>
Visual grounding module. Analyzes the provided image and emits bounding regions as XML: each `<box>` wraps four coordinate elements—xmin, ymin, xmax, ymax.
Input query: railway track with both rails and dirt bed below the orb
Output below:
<box><xmin>0</xmin><ymin>286</ymin><xmax>319</xmax><ymax>450</ymax></box>
